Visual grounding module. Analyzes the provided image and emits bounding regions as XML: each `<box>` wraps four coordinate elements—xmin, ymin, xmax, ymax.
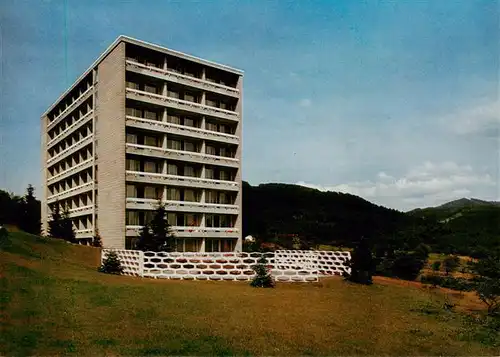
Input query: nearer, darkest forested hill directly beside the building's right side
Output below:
<box><xmin>243</xmin><ymin>182</ymin><xmax>409</xmax><ymax>246</ymax></box>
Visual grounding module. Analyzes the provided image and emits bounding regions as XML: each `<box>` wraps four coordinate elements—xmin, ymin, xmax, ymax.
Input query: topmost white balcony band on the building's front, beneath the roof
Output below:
<box><xmin>126</xmin><ymin>59</ymin><xmax>240</xmax><ymax>98</ymax></box>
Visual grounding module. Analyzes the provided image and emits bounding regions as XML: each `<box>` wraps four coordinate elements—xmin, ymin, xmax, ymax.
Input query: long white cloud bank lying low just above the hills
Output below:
<box><xmin>297</xmin><ymin>161</ymin><xmax>496</xmax><ymax>210</ymax></box>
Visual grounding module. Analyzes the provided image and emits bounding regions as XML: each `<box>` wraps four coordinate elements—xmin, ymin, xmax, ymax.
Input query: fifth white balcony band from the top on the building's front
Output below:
<box><xmin>126</xmin><ymin>171</ymin><xmax>240</xmax><ymax>191</ymax></box>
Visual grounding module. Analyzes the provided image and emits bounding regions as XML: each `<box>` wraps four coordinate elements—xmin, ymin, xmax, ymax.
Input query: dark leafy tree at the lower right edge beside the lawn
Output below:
<box><xmin>471</xmin><ymin>248</ymin><xmax>500</xmax><ymax>315</ymax></box>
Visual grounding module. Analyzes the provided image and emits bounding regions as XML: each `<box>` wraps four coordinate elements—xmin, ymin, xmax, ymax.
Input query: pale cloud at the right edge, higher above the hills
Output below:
<box><xmin>443</xmin><ymin>101</ymin><xmax>500</xmax><ymax>138</ymax></box>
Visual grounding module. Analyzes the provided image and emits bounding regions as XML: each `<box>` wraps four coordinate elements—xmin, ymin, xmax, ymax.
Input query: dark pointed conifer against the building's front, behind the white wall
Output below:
<box><xmin>136</xmin><ymin>202</ymin><xmax>175</xmax><ymax>252</ymax></box>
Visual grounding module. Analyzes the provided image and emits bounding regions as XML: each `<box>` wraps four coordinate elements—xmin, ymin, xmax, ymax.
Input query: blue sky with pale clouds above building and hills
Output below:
<box><xmin>0</xmin><ymin>0</ymin><xmax>500</xmax><ymax>210</ymax></box>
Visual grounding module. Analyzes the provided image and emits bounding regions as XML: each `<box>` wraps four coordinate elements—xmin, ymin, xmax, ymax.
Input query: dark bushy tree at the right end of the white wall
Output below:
<box><xmin>344</xmin><ymin>237</ymin><xmax>375</xmax><ymax>285</ymax></box>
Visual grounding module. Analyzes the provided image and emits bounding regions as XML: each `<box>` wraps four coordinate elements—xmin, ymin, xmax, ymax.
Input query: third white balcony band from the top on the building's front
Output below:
<box><xmin>126</xmin><ymin>115</ymin><xmax>239</xmax><ymax>145</ymax></box>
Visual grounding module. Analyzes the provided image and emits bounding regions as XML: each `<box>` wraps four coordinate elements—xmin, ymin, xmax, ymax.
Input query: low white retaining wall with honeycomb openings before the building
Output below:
<box><xmin>101</xmin><ymin>249</ymin><xmax>350</xmax><ymax>282</ymax></box>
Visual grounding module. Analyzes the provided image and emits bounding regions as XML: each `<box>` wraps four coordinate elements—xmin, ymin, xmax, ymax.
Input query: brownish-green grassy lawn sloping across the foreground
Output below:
<box><xmin>0</xmin><ymin>232</ymin><xmax>499</xmax><ymax>356</ymax></box>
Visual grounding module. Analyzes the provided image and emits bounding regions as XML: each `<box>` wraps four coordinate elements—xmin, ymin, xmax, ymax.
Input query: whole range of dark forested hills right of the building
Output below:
<box><xmin>243</xmin><ymin>182</ymin><xmax>500</xmax><ymax>257</ymax></box>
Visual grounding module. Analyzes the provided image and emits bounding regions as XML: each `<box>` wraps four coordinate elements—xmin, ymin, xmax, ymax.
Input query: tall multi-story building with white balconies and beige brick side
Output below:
<box><xmin>41</xmin><ymin>36</ymin><xmax>243</xmax><ymax>252</ymax></box>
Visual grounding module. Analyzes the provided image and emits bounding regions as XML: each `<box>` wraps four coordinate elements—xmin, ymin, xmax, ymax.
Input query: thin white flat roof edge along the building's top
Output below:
<box><xmin>42</xmin><ymin>35</ymin><xmax>243</xmax><ymax>118</ymax></box>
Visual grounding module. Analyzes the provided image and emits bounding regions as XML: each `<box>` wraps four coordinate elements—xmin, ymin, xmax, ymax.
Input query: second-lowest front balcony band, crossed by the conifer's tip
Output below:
<box><xmin>127</xmin><ymin>198</ymin><xmax>239</xmax><ymax>214</ymax></box>
